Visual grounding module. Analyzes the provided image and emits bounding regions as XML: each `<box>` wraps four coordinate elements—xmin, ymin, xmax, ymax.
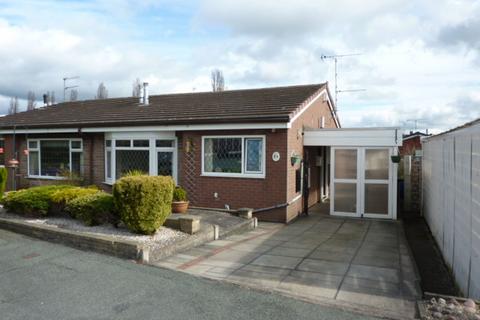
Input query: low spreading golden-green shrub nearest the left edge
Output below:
<box><xmin>2</xmin><ymin>185</ymin><xmax>71</xmax><ymax>216</ymax></box>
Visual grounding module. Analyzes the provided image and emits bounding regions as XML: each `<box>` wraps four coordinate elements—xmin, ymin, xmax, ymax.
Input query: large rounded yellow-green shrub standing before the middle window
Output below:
<box><xmin>113</xmin><ymin>175</ymin><xmax>175</xmax><ymax>234</ymax></box>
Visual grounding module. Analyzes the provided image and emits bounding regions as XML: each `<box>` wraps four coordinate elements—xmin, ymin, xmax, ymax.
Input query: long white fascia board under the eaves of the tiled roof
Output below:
<box><xmin>0</xmin><ymin>122</ymin><xmax>289</xmax><ymax>134</ymax></box>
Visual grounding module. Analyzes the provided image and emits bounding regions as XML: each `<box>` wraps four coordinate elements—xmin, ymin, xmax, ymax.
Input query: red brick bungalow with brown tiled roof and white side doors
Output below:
<box><xmin>0</xmin><ymin>83</ymin><xmax>401</xmax><ymax>222</ymax></box>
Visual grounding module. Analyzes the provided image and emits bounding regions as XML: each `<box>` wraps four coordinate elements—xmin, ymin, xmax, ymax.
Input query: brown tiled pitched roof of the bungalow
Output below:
<box><xmin>0</xmin><ymin>83</ymin><xmax>327</xmax><ymax>129</ymax></box>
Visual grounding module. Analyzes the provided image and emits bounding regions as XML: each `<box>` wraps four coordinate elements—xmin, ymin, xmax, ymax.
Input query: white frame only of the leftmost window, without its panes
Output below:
<box><xmin>27</xmin><ymin>138</ymin><xmax>83</xmax><ymax>180</ymax></box>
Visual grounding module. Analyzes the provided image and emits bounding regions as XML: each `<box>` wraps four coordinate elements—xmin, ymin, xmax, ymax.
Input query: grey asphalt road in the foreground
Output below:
<box><xmin>0</xmin><ymin>230</ymin><xmax>382</xmax><ymax>320</ymax></box>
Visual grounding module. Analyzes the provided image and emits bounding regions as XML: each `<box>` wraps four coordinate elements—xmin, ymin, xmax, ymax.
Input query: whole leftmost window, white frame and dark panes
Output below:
<box><xmin>27</xmin><ymin>139</ymin><xmax>83</xmax><ymax>179</ymax></box>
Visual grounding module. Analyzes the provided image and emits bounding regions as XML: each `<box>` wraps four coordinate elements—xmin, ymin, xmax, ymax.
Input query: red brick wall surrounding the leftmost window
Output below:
<box><xmin>4</xmin><ymin>133</ymin><xmax>108</xmax><ymax>190</ymax></box>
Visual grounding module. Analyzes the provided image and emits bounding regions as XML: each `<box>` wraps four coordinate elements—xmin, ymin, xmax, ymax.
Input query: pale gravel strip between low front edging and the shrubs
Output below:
<box><xmin>0</xmin><ymin>208</ymin><xmax>189</xmax><ymax>247</ymax></box>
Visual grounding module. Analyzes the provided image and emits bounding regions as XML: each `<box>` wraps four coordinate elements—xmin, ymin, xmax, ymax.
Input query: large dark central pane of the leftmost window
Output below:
<box><xmin>40</xmin><ymin>140</ymin><xmax>70</xmax><ymax>176</ymax></box>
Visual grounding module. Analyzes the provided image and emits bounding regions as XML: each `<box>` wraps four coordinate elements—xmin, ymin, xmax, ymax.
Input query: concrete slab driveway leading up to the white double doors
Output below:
<box><xmin>157</xmin><ymin>206</ymin><xmax>421</xmax><ymax>318</ymax></box>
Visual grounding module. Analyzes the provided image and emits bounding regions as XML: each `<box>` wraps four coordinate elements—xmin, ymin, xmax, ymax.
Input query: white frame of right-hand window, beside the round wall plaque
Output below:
<box><xmin>201</xmin><ymin>135</ymin><xmax>267</xmax><ymax>179</ymax></box>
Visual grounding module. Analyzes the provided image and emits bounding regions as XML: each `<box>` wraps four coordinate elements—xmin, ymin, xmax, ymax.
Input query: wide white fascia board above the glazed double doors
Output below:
<box><xmin>303</xmin><ymin>128</ymin><xmax>402</xmax><ymax>147</ymax></box>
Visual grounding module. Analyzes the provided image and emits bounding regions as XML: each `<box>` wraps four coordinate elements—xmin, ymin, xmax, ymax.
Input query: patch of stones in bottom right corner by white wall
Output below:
<box><xmin>423</xmin><ymin>298</ymin><xmax>480</xmax><ymax>320</ymax></box>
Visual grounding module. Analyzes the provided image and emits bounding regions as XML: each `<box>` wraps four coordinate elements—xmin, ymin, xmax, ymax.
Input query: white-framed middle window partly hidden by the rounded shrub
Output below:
<box><xmin>105</xmin><ymin>133</ymin><xmax>177</xmax><ymax>184</ymax></box>
